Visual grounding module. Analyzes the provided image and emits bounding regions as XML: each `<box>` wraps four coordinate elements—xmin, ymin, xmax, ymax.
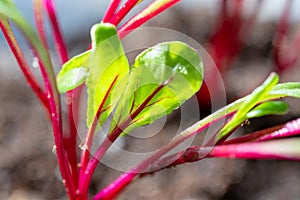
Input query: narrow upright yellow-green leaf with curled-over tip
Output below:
<box><xmin>86</xmin><ymin>23</ymin><xmax>129</xmax><ymax>127</ymax></box>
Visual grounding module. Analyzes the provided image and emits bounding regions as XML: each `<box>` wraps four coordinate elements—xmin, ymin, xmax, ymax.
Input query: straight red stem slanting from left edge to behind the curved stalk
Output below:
<box><xmin>0</xmin><ymin>19</ymin><xmax>50</xmax><ymax>116</ymax></box>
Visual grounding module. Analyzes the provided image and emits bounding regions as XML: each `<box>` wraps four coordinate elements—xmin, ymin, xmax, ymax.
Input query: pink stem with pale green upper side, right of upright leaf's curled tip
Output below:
<box><xmin>119</xmin><ymin>0</ymin><xmax>180</xmax><ymax>38</ymax></box>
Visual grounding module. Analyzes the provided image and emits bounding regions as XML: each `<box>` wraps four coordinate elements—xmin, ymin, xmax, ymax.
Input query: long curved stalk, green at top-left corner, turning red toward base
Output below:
<box><xmin>0</xmin><ymin>1</ymin><xmax>75</xmax><ymax>199</ymax></box>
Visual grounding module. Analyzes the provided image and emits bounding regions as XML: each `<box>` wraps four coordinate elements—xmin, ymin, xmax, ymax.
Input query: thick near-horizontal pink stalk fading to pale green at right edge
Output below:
<box><xmin>150</xmin><ymin>138</ymin><xmax>300</xmax><ymax>170</ymax></box>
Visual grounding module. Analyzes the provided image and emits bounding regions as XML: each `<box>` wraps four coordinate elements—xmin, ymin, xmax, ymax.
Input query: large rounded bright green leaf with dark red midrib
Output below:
<box><xmin>111</xmin><ymin>42</ymin><xmax>203</xmax><ymax>133</ymax></box>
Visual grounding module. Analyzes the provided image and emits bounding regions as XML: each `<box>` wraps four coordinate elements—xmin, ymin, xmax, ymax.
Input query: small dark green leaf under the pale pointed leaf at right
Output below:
<box><xmin>246</xmin><ymin>101</ymin><xmax>289</xmax><ymax>119</ymax></box>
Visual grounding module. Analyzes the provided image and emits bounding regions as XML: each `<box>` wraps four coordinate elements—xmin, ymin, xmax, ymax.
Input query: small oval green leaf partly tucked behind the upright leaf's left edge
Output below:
<box><xmin>57</xmin><ymin>51</ymin><xmax>91</xmax><ymax>93</ymax></box>
